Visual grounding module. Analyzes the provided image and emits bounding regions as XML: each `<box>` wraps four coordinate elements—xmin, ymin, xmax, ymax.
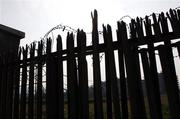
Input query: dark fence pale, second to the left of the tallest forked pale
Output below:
<box><xmin>67</xmin><ymin>33</ymin><xmax>78</xmax><ymax>119</ymax></box>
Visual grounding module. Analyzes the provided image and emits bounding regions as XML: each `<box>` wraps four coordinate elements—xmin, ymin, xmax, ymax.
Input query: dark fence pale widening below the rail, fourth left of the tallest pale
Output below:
<box><xmin>46</xmin><ymin>38</ymin><xmax>60</xmax><ymax>119</ymax></box>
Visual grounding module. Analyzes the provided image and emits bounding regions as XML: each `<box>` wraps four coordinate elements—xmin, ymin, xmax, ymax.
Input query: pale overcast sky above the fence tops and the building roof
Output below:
<box><xmin>0</xmin><ymin>0</ymin><xmax>180</xmax><ymax>44</ymax></box>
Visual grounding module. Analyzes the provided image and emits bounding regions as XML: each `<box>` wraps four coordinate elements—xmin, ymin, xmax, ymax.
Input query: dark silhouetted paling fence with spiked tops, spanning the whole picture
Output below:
<box><xmin>0</xmin><ymin>10</ymin><xmax>180</xmax><ymax>119</ymax></box>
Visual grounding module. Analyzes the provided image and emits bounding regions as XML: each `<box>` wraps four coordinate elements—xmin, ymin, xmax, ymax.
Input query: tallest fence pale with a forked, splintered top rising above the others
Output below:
<box><xmin>91</xmin><ymin>10</ymin><xmax>103</xmax><ymax>119</ymax></box>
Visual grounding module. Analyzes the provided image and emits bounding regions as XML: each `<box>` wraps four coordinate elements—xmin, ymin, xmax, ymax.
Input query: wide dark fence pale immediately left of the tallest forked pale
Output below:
<box><xmin>77</xmin><ymin>30</ymin><xmax>89</xmax><ymax>119</ymax></box>
